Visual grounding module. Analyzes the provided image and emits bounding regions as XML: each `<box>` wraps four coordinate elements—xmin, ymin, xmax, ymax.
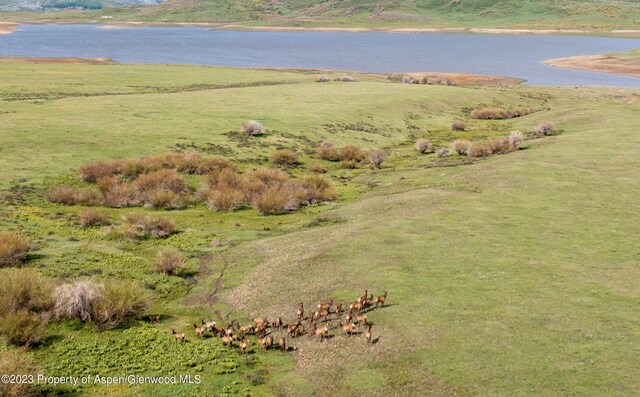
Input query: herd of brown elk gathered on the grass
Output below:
<box><xmin>171</xmin><ymin>290</ymin><xmax>387</xmax><ymax>353</ymax></box>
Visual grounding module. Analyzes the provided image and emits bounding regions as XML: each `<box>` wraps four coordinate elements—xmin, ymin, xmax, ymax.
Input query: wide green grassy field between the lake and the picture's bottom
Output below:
<box><xmin>0</xmin><ymin>62</ymin><xmax>640</xmax><ymax>396</ymax></box>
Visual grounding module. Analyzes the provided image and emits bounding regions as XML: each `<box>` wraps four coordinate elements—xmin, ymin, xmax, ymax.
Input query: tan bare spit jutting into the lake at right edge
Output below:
<box><xmin>542</xmin><ymin>54</ymin><xmax>640</xmax><ymax>78</ymax></box>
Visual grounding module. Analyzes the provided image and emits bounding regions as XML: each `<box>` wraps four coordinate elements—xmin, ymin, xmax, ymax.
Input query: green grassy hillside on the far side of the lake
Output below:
<box><xmin>5</xmin><ymin>0</ymin><xmax>640</xmax><ymax>30</ymax></box>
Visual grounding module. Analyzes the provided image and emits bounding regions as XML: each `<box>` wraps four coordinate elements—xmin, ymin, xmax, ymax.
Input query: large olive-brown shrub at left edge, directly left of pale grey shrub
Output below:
<box><xmin>0</xmin><ymin>269</ymin><xmax>55</xmax><ymax>316</ymax></box>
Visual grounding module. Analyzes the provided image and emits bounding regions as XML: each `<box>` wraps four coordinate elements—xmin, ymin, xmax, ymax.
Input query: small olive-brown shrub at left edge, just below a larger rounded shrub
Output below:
<box><xmin>0</xmin><ymin>310</ymin><xmax>46</xmax><ymax>347</ymax></box>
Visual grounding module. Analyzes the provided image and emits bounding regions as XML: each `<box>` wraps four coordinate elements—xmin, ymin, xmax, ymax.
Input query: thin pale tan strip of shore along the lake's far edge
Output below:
<box><xmin>0</xmin><ymin>19</ymin><xmax>640</xmax><ymax>38</ymax></box>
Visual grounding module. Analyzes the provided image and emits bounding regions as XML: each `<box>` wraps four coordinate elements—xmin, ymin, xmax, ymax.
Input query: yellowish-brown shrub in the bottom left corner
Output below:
<box><xmin>0</xmin><ymin>350</ymin><xmax>41</xmax><ymax>397</ymax></box>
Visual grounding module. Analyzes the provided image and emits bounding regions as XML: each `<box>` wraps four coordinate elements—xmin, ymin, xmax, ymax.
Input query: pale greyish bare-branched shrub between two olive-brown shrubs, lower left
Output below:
<box><xmin>55</xmin><ymin>280</ymin><xmax>104</xmax><ymax>322</ymax></box>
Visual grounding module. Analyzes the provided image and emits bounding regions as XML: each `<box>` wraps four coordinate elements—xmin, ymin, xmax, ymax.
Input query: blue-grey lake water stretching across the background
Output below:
<box><xmin>0</xmin><ymin>25</ymin><xmax>640</xmax><ymax>88</ymax></box>
